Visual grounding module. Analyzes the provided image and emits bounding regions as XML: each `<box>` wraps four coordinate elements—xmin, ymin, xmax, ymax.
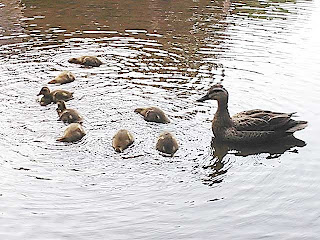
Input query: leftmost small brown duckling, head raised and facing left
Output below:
<box><xmin>38</xmin><ymin>87</ymin><xmax>73</xmax><ymax>106</ymax></box>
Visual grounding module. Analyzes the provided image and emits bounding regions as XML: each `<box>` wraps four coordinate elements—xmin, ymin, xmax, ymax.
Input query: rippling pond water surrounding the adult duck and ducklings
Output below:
<box><xmin>0</xmin><ymin>0</ymin><xmax>320</xmax><ymax>240</ymax></box>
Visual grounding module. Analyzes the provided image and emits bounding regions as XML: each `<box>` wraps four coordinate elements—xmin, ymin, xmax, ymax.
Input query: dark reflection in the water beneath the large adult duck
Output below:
<box><xmin>203</xmin><ymin>135</ymin><xmax>306</xmax><ymax>186</ymax></box>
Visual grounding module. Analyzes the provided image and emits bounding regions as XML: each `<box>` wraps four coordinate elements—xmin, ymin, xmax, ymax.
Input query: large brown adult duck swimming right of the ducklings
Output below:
<box><xmin>197</xmin><ymin>84</ymin><xmax>307</xmax><ymax>144</ymax></box>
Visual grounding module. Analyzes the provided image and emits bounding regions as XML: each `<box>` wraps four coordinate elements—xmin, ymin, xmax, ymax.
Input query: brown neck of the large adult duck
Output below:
<box><xmin>212</xmin><ymin>99</ymin><xmax>232</xmax><ymax>131</ymax></box>
